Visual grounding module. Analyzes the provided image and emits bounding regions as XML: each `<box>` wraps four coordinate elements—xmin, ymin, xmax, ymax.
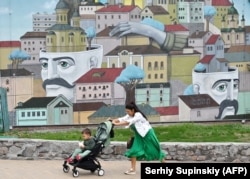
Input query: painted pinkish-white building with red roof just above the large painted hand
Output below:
<box><xmin>95</xmin><ymin>4</ymin><xmax>141</xmax><ymax>33</ymax></box>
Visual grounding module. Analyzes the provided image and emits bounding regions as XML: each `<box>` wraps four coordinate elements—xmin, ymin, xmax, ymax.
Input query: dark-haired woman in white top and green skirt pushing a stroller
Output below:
<box><xmin>112</xmin><ymin>102</ymin><xmax>166</xmax><ymax>175</ymax></box>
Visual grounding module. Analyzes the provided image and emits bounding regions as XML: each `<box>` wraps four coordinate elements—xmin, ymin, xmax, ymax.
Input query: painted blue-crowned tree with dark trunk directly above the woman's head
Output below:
<box><xmin>115</xmin><ymin>65</ymin><xmax>145</xmax><ymax>104</ymax></box>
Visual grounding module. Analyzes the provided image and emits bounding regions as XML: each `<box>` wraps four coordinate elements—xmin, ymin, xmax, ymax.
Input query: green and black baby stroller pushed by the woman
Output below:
<box><xmin>63</xmin><ymin>121</ymin><xmax>114</xmax><ymax>177</ymax></box>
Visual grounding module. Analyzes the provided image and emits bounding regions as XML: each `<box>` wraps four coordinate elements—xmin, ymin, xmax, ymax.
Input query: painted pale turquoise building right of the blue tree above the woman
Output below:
<box><xmin>135</xmin><ymin>83</ymin><xmax>170</xmax><ymax>107</ymax></box>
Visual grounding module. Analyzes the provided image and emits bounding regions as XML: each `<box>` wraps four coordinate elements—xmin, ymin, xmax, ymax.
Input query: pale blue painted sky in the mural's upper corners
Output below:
<box><xmin>0</xmin><ymin>0</ymin><xmax>250</xmax><ymax>40</ymax></box>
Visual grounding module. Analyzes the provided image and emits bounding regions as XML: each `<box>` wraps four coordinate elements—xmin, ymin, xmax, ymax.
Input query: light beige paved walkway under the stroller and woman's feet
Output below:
<box><xmin>0</xmin><ymin>160</ymin><xmax>145</xmax><ymax>179</ymax></box>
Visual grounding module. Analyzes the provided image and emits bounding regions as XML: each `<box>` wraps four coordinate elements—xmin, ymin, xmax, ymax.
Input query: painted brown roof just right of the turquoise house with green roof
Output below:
<box><xmin>73</xmin><ymin>102</ymin><xmax>107</xmax><ymax>111</ymax></box>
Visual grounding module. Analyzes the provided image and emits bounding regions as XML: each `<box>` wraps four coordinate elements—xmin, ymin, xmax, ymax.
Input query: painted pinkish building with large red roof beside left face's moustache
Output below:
<box><xmin>75</xmin><ymin>68</ymin><xmax>126</xmax><ymax>105</ymax></box>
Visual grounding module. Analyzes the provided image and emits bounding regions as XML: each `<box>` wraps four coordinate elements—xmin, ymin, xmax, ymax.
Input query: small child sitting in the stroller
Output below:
<box><xmin>67</xmin><ymin>128</ymin><xmax>95</xmax><ymax>163</ymax></box>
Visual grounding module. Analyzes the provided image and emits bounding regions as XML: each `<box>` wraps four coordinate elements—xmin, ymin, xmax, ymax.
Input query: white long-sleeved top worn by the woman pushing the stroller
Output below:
<box><xmin>118</xmin><ymin>112</ymin><xmax>152</xmax><ymax>137</ymax></box>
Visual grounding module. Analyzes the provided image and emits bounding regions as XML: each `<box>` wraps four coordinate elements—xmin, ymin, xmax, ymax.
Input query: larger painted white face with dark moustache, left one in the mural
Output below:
<box><xmin>39</xmin><ymin>44</ymin><xmax>103</xmax><ymax>101</ymax></box>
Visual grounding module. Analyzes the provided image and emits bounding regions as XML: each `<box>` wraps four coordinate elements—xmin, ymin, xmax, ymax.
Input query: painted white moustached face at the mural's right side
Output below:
<box><xmin>192</xmin><ymin>68</ymin><xmax>239</xmax><ymax>119</ymax></box>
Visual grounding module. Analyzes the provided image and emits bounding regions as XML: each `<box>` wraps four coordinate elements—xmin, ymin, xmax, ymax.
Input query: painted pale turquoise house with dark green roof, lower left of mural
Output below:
<box><xmin>15</xmin><ymin>95</ymin><xmax>74</xmax><ymax>126</ymax></box>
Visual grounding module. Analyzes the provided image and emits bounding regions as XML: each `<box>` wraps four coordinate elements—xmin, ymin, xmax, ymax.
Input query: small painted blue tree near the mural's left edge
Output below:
<box><xmin>9</xmin><ymin>49</ymin><xmax>30</xmax><ymax>69</ymax></box>
